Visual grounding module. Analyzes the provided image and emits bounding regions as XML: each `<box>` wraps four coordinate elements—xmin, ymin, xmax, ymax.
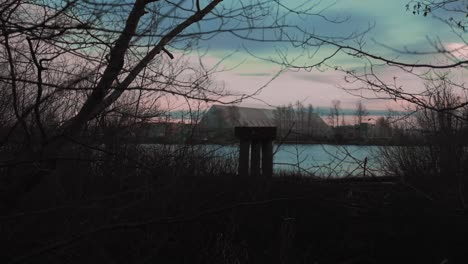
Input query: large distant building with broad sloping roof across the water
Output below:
<box><xmin>198</xmin><ymin>105</ymin><xmax>331</xmax><ymax>142</ymax></box>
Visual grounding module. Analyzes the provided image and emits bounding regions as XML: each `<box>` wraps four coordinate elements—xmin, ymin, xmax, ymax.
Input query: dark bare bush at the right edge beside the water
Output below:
<box><xmin>379</xmin><ymin>77</ymin><xmax>468</xmax><ymax>203</ymax></box>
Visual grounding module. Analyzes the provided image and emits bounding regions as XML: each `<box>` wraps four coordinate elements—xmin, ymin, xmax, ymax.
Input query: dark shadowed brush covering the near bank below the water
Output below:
<box><xmin>0</xmin><ymin>142</ymin><xmax>468</xmax><ymax>263</ymax></box>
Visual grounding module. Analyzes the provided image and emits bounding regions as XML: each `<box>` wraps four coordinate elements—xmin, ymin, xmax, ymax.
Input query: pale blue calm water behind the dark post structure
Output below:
<box><xmin>210</xmin><ymin>144</ymin><xmax>382</xmax><ymax>177</ymax></box>
